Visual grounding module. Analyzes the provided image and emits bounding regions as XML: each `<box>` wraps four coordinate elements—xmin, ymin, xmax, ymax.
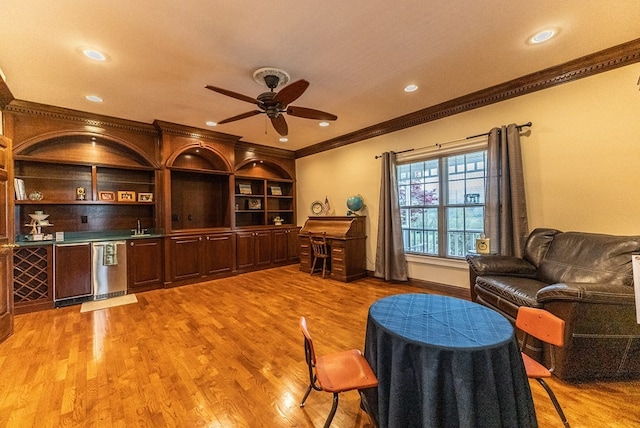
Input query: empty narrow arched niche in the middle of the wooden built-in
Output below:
<box><xmin>166</xmin><ymin>145</ymin><xmax>233</xmax><ymax>231</ymax></box>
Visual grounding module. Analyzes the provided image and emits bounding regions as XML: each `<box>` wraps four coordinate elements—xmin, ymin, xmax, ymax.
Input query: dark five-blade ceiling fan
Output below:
<box><xmin>205</xmin><ymin>68</ymin><xmax>338</xmax><ymax>137</ymax></box>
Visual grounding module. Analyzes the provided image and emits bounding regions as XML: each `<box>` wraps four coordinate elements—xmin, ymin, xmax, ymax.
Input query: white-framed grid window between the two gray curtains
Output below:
<box><xmin>397</xmin><ymin>150</ymin><xmax>487</xmax><ymax>258</ymax></box>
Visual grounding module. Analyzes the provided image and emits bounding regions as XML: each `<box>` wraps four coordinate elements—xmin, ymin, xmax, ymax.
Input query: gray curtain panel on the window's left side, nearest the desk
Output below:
<box><xmin>374</xmin><ymin>152</ymin><xmax>407</xmax><ymax>281</ymax></box>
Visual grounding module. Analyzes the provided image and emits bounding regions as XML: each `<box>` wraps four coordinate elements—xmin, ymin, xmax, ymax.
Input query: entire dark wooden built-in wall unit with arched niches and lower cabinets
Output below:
<box><xmin>5</xmin><ymin>105</ymin><xmax>299</xmax><ymax>311</ymax></box>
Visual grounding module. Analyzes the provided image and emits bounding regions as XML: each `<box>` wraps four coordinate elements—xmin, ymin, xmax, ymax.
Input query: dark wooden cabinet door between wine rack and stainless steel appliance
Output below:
<box><xmin>53</xmin><ymin>244</ymin><xmax>92</xmax><ymax>300</ymax></box>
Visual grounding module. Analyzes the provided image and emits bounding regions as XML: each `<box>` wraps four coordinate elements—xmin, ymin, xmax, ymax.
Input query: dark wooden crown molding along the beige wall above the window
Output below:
<box><xmin>295</xmin><ymin>39</ymin><xmax>640</xmax><ymax>159</ymax></box>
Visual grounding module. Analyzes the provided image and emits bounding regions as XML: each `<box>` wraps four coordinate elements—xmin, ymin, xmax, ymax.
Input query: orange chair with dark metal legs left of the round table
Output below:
<box><xmin>300</xmin><ymin>317</ymin><xmax>378</xmax><ymax>428</ymax></box>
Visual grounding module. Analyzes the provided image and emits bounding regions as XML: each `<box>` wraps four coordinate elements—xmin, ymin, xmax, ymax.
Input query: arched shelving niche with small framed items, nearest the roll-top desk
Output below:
<box><xmin>234</xmin><ymin>159</ymin><xmax>296</xmax><ymax>227</ymax></box>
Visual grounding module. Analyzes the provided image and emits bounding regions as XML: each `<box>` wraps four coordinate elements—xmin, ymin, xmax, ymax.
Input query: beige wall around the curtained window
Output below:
<box><xmin>296</xmin><ymin>64</ymin><xmax>640</xmax><ymax>287</ymax></box>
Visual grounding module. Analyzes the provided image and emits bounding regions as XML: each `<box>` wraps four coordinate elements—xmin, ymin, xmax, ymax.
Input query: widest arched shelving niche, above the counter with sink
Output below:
<box><xmin>13</xmin><ymin>131</ymin><xmax>159</xmax><ymax>238</ymax></box>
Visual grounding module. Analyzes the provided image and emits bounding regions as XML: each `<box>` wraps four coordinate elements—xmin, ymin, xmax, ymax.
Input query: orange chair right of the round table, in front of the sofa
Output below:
<box><xmin>516</xmin><ymin>306</ymin><xmax>569</xmax><ymax>428</ymax></box>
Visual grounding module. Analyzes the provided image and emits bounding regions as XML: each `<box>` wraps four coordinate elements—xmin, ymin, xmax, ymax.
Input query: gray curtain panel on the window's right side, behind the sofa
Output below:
<box><xmin>484</xmin><ymin>124</ymin><xmax>529</xmax><ymax>257</ymax></box>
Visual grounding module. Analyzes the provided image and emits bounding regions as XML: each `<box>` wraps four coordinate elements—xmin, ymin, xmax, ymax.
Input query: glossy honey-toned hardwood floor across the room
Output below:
<box><xmin>0</xmin><ymin>265</ymin><xmax>640</xmax><ymax>428</ymax></box>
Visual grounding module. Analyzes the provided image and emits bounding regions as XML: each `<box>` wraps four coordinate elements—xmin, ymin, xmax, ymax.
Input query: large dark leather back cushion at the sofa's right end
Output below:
<box><xmin>538</xmin><ymin>232</ymin><xmax>640</xmax><ymax>286</ymax></box>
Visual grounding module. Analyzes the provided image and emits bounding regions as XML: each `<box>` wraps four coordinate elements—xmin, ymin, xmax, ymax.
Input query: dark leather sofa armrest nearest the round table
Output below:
<box><xmin>536</xmin><ymin>282</ymin><xmax>635</xmax><ymax>305</ymax></box>
